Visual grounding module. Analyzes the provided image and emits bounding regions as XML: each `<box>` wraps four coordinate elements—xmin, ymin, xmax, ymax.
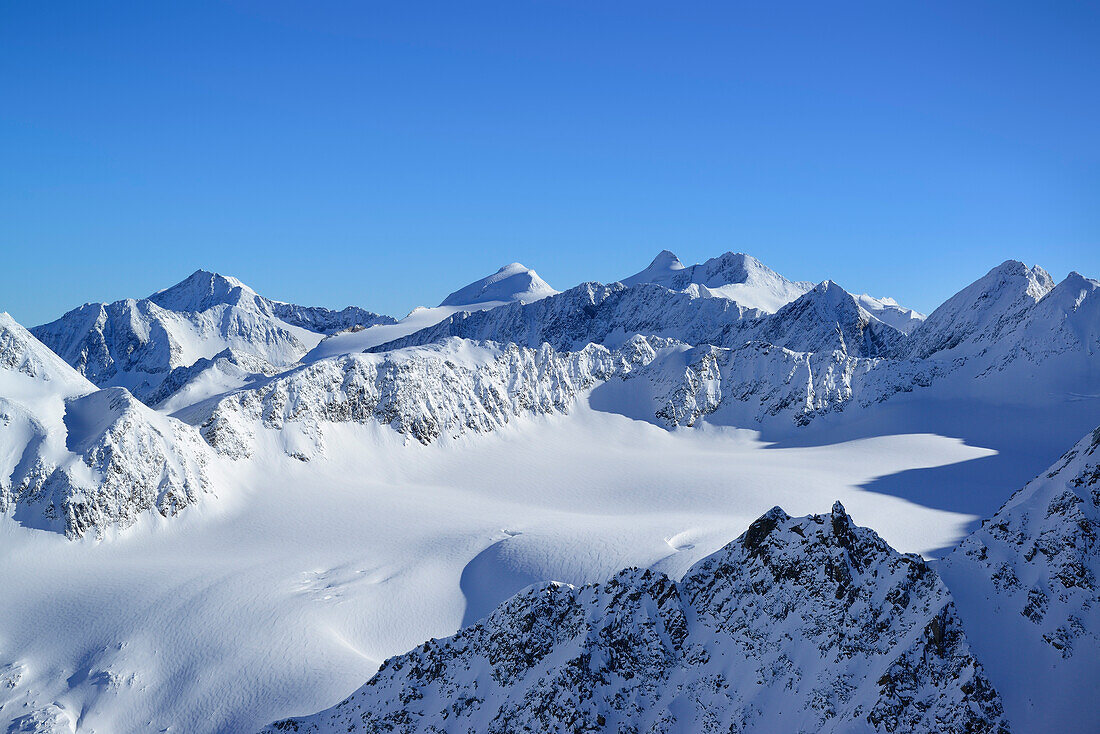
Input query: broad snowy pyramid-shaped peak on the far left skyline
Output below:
<box><xmin>32</xmin><ymin>271</ymin><xmax>393</xmax><ymax>402</ymax></box>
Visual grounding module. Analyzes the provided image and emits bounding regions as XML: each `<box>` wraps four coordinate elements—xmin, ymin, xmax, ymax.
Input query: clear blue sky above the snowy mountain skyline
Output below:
<box><xmin>0</xmin><ymin>0</ymin><xmax>1100</xmax><ymax>325</ymax></box>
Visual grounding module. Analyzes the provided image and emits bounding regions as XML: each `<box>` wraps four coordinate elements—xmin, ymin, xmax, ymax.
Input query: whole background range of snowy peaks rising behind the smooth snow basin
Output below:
<box><xmin>10</xmin><ymin>253</ymin><xmax>1100</xmax><ymax>530</ymax></box>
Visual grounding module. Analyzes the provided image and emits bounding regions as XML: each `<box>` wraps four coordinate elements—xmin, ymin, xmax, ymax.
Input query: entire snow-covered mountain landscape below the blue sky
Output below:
<box><xmin>0</xmin><ymin>252</ymin><xmax>1100</xmax><ymax>734</ymax></box>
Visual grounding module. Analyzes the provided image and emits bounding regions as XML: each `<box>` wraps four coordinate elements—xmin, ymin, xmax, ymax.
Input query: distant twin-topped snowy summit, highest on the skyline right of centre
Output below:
<box><xmin>622</xmin><ymin>250</ymin><xmax>813</xmax><ymax>314</ymax></box>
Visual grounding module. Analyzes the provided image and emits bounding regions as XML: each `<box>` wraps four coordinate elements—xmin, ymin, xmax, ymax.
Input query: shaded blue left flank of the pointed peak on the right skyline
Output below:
<box><xmin>904</xmin><ymin>260</ymin><xmax>1054</xmax><ymax>359</ymax></box>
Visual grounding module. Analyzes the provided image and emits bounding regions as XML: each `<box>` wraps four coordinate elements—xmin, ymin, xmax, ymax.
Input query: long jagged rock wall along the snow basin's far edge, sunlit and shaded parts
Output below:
<box><xmin>191</xmin><ymin>327</ymin><xmax>939</xmax><ymax>459</ymax></box>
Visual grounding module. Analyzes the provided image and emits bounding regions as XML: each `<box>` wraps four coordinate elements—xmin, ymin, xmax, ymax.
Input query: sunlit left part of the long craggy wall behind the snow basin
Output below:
<box><xmin>190</xmin><ymin>337</ymin><xmax>668</xmax><ymax>460</ymax></box>
